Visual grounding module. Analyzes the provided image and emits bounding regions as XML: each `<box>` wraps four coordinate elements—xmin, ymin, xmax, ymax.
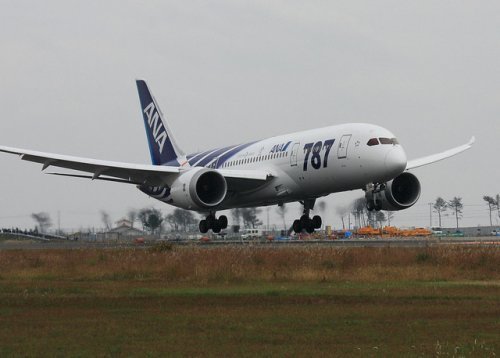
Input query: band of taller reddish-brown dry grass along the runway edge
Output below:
<box><xmin>0</xmin><ymin>247</ymin><xmax>500</xmax><ymax>284</ymax></box>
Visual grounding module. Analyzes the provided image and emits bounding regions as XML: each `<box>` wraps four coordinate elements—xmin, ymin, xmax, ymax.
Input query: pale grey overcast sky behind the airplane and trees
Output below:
<box><xmin>0</xmin><ymin>0</ymin><xmax>500</xmax><ymax>228</ymax></box>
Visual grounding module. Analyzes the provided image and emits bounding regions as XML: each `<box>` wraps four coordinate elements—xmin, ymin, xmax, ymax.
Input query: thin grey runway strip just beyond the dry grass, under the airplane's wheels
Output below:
<box><xmin>0</xmin><ymin>236</ymin><xmax>500</xmax><ymax>250</ymax></box>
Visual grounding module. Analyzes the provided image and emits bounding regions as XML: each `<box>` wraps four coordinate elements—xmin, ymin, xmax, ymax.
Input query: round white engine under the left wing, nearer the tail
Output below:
<box><xmin>170</xmin><ymin>167</ymin><xmax>227</xmax><ymax>210</ymax></box>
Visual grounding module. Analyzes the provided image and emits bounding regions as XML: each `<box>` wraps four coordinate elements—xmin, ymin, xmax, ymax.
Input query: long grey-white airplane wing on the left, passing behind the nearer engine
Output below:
<box><xmin>0</xmin><ymin>146</ymin><xmax>272</xmax><ymax>186</ymax></box>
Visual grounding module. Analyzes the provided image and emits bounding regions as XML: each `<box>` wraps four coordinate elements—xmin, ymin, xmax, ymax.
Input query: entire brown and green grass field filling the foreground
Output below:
<box><xmin>0</xmin><ymin>245</ymin><xmax>500</xmax><ymax>357</ymax></box>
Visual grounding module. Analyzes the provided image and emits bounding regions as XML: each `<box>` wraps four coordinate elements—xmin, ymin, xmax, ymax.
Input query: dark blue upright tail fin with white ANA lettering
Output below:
<box><xmin>136</xmin><ymin>80</ymin><xmax>184</xmax><ymax>165</ymax></box>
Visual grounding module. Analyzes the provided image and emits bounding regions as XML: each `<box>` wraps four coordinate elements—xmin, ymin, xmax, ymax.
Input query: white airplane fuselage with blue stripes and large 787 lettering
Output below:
<box><xmin>153</xmin><ymin>123</ymin><xmax>406</xmax><ymax>210</ymax></box>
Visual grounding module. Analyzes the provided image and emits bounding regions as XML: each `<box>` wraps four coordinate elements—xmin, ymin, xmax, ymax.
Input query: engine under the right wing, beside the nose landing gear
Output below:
<box><xmin>366</xmin><ymin>172</ymin><xmax>420</xmax><ymax>211</ymax></box>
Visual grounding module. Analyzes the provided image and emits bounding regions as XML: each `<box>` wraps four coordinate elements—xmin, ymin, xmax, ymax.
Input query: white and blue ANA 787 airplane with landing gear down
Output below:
<box><xmin>0</xmin><ymin>80</ymin><xmax>475</xmax><ymax>233</ymax></box>
